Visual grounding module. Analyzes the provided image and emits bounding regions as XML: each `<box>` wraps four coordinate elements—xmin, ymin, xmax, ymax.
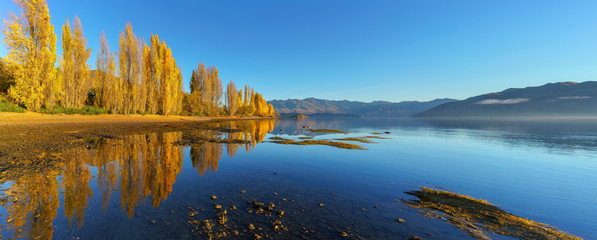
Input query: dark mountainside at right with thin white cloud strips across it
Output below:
<box><xmin>416</xmin><ymin>81</ymin><xmax>597</xmax><ymax>117</ymax></box>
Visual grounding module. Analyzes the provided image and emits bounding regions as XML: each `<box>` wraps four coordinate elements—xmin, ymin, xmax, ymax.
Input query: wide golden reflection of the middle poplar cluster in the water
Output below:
<box><xmin>94</xmin><ymin>132</ymin><xmax>182</xmax><ymax>217</ymax></box>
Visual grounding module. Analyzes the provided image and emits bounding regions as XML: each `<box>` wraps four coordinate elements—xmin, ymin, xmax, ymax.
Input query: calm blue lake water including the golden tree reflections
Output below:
<box><xmin>0</xmin><ymin>118</ymin><xmax>597</xmax><ymax>239</ymax></box>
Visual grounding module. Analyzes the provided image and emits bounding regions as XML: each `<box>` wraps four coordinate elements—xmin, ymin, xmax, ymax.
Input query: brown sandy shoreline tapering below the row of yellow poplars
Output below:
<box><xmin>0</xmin><ymin>113</ymin><xmax>270</xmax><ymax>163</ymax></box>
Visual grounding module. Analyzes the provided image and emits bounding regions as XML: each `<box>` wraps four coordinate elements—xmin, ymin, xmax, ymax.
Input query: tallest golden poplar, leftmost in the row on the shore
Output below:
<box><xmin>4</xmin><ymin>0</ymin><xmax>56</xmax><ymax>110</ymax></box>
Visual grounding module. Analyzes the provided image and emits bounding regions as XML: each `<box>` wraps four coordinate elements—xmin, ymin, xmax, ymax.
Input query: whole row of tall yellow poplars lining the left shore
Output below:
<box><xmin>3</xmin><ymin>0</ymin><xmax>275</xmax><ymax>116</ymax></box>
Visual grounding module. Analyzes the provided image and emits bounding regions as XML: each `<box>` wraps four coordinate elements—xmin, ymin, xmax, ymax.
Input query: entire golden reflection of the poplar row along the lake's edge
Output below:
<box><xmin>0</xmin><ymin>120</ymin><xmax>274</xmax><ymax>239</ymax></box>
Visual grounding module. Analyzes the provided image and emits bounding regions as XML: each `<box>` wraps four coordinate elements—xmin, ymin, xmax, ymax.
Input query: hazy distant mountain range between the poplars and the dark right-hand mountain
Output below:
<box><xmin>268</xmin><ymin>98</ymin><xmax>456</xmax><ymax>117</ymax></box>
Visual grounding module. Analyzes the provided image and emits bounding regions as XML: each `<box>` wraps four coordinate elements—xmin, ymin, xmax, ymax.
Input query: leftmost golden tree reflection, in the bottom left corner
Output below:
<box><xmin>6</xmin><ymin>171</ymin><xmax>59</xmax><ymax>239</ymax></box>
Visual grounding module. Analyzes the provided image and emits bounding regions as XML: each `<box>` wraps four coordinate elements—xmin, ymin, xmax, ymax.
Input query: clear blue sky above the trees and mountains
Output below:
<box><xmin>0</xmin><ymin>0</ymin><xmax>597</xmax><ymax>101</ymax></box>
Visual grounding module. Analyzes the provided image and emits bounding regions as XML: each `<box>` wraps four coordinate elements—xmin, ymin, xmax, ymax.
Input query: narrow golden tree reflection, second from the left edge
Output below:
<box><xmin>62</xmin><ymin>149</ymin><xmax>93</xmax><ymax>228</ymax></box>
